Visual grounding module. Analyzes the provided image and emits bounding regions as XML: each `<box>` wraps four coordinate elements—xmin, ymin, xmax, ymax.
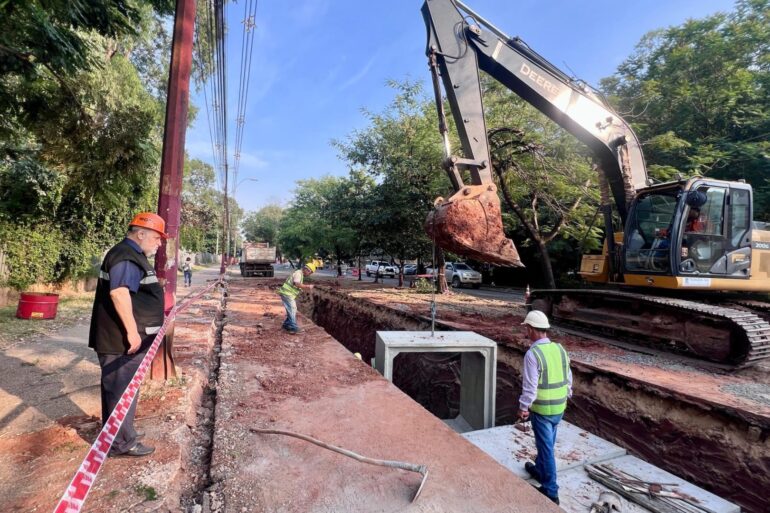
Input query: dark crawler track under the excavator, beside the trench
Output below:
<box><xmin>529</xmin><ymin>289</ymin><xmax>770</xmax><ymax>369</ymax></box>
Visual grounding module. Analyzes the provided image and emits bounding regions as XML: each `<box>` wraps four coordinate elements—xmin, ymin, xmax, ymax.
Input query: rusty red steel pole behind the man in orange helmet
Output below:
<box><xmin>150</xmin><ymin>0</ymin><xmax>195</xmax><ymax>379</ymax></box>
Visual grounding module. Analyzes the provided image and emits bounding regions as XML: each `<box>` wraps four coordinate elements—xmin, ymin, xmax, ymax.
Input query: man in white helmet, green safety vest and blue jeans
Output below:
<box><xmin>518</xmin><ymin>310</ymin><xmax>572</xmax><ymax>504</ymax></box>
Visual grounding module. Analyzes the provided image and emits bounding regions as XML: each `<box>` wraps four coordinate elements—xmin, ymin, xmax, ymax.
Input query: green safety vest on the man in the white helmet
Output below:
<box><xmin>529</xmin><ymin>342</ymin><xmax>569</xmax><ymax>415</ymax></box>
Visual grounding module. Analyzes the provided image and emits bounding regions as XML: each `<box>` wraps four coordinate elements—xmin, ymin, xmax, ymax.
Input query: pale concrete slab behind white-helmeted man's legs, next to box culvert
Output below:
<box><xmin>463</xmin><ymin>421</ymin><xmax>626</xmax><ymax>479</ymax></box>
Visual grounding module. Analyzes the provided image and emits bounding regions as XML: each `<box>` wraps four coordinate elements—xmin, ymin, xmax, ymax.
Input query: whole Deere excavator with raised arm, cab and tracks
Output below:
<box><xmin>422</xmin><ymin>0</ymin><xmax>770</xmax><ymax>368</ymax></box>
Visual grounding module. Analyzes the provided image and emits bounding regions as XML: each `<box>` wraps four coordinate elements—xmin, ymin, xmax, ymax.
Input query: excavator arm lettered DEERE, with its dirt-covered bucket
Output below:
<box><xmin>422</xmin><ymin>0</ymin><xmax>648</xmax><ymax>265</ymax></box>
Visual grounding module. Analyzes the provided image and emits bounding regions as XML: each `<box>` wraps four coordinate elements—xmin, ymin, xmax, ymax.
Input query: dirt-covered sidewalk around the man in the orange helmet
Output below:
<box><xmin>0</xmin><ymin>266</ymin><xmax>221</xmax><ymax>511</ymax></box>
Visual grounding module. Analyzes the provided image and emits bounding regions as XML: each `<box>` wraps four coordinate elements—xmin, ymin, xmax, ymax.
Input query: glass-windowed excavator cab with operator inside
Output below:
<box><xmin>623</xmin><ymin>179</ymin><xmax>752</xmax><ymax>284</ymax></box>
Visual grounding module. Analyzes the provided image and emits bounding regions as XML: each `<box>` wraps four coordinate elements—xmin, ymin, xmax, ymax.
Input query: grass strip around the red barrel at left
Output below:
<box><xmin>0</xmin><ymin>292</ymin><xmax>94</xmax><ymax>349</ymax></box>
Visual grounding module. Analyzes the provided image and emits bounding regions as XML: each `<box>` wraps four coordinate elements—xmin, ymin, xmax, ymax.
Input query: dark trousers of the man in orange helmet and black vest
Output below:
<box><xmin>97</xmin><ymin>349</ymin><xmax>147</xmax><ymax>453</ymax></box>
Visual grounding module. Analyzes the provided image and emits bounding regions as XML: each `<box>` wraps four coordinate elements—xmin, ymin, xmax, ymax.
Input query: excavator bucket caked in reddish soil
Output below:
<box><xmin>425</xmin><ymin>185</ymin><xmax>523</xmax><ymax>267</ymax></box>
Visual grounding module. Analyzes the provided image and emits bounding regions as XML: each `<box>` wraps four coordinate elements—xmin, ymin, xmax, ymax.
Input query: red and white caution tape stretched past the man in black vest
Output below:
<box><xmin>54</xmin><ymin>277</ymin><xmax>222</xmax><ymax>513</ymax></box>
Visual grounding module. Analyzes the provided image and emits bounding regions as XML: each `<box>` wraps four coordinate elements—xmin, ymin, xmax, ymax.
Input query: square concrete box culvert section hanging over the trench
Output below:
<box><xmin>375</xmin><ymin>331</ymin><xmax>497</xmax><ymax>429</ymax></box>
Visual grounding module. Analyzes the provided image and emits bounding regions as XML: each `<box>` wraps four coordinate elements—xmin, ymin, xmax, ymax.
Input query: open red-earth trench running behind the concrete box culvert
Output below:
<box><xmin>300</xmin><ymin>287</ymin><xmax>770</xmax><ymax>513</ymax></box>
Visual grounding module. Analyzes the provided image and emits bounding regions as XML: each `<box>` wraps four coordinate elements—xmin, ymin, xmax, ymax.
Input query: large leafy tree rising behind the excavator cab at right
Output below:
<box><xmin>602</xmin><ymin>0</ymin><xmax>770</xmax><ymax>220</ymax></box>
